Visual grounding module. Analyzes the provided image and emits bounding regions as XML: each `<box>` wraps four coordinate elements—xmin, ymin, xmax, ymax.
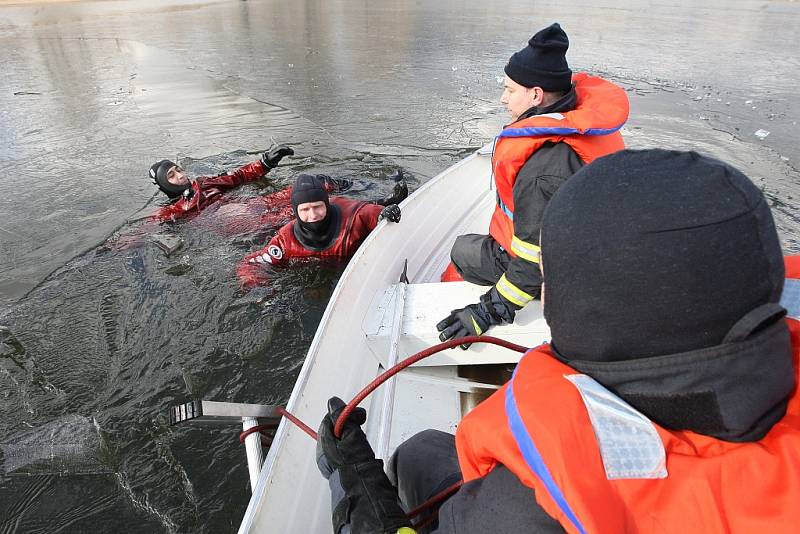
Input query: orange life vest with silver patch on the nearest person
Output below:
<box><xmin>456</xmin><ymin>257</ymin><xmax>800</xmax><ymax>534</ymax></box>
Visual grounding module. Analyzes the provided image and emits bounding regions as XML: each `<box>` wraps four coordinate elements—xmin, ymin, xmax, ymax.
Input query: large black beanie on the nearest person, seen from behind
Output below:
<box><xmin>541</xmin><ymin>150</ymin><xmax>784</xmax><ymax>361</ymax></box>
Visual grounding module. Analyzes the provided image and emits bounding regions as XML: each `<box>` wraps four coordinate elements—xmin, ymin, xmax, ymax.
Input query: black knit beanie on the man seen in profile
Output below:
<box><xmin>505</xmin><ymin>22</ymin><xmax>572</xmax><ymax>92</ymax></box>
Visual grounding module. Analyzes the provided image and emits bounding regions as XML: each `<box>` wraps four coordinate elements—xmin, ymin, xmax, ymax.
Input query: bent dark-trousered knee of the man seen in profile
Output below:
<box><xmin>450</xmin><ymin>234</ymin><xmax>511</xmax><ymax>286</ymax></box>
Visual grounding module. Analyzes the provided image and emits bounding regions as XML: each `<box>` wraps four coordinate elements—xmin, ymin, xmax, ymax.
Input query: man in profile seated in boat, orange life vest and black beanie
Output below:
<box><xmin>437</xmin><ymin>23</ymin><xmax>629</xmax><ymax>349</ymax></box>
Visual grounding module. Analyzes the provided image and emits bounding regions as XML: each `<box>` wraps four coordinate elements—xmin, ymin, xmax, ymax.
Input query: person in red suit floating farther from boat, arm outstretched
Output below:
<box><xmin>149</xmin><ymin>145</ymin><xmax>294</xmax><ymax>222</ymax></box>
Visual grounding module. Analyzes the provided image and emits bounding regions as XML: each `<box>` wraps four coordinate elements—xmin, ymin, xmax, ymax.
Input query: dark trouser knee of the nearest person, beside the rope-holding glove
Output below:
<box><xmin>386</xmin><ymin>429</ymin><xmax>462</xmax><ymax>534</ymax></box>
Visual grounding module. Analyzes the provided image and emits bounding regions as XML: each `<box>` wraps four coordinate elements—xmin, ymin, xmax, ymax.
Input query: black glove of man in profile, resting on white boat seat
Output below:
<box><xmin>436</xmin><ymin>287</ymin><xmax>516</xmax><ymax>350</ymax></box>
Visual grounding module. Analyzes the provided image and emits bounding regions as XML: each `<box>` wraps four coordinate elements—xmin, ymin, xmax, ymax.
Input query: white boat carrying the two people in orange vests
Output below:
<box><xmin>239</xmin><ymin>147</ymin><xmax>550</xmax><ymax>534</ymax></box>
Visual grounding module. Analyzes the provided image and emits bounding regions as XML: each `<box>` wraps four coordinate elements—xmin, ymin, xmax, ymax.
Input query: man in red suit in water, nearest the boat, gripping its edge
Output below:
<box><xmin>237</xmin><ymin>174</ymin><xmax>408</xmax><ymax>287</ymax></box>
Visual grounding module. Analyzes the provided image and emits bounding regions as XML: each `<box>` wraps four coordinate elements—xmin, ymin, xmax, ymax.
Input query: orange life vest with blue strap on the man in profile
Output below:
<box><xmin>489</xmin><ymin>73</ymin><xmax>629</xmax><ymax>256</ymax></box>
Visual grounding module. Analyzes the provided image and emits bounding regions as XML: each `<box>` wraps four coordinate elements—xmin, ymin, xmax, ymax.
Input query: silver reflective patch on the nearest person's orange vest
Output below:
<box><xmin>565</xmin><ymin>374</ymin><xmax>667</xmax><ymax>480</ymax></box>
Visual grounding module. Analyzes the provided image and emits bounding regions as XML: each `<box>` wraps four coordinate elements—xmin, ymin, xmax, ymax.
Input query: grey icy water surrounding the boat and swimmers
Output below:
<box><xmin>0</xmin><ymin>0</ymin><xmax>800</xmax><ymax>534</ymax></box>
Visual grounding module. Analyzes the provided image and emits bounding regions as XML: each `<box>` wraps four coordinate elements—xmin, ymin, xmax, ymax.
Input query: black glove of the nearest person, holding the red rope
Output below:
<box><xmin>317</xmin><ymin>397</ymin><xmax>411</xmax><ymax>534</ymax></box>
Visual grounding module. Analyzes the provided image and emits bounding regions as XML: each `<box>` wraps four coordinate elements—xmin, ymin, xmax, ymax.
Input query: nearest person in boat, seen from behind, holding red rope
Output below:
<box><xmin>317</xmin><ymin>150</ymin><xmax>800</xmax><ymax>534</ymax></box>
